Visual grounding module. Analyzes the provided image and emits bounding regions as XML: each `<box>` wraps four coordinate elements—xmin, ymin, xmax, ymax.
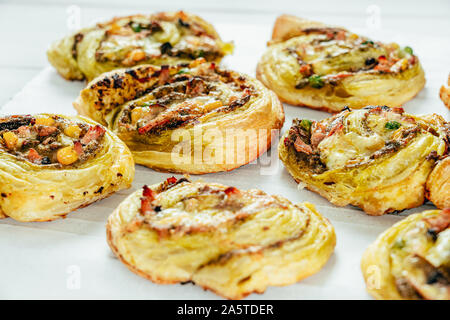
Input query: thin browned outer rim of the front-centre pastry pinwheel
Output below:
<box><xmin>106</xmin><ymin>176</ymin><xmax>336</xmax><ymax>300</ymax></box>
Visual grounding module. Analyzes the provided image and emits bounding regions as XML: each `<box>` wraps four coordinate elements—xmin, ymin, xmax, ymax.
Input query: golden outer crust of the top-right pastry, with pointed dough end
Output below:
<box><xmin>256</xmin><ymin>14</ymin><xmax>425</xmax><ymax>113</ymax></box>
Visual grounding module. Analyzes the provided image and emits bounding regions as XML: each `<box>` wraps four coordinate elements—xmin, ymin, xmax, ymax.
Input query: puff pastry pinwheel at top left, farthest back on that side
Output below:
<box><xmin>47</xmin><ymin>11</ymin><xmax>233</xmax><ymax>80</ymax></box>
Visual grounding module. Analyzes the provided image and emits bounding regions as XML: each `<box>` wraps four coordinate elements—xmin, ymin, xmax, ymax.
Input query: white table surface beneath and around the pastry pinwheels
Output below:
<box><xmin>0</xmin><ymin>0</ymin><xmax>450</xmax><ymax>299</ymax></box>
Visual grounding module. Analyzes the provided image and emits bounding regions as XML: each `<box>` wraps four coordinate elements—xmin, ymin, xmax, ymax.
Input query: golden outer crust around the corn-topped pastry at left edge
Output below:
<box><xmin>0</xmin><ymin>113</ymin><xmax>134</xmax><ymax>222</ymax></box>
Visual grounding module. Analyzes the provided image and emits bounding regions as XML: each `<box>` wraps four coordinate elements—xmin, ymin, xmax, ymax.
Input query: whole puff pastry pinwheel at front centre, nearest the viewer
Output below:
<box><xmin>107</xmin><ymin>177</ymin><xmax>336</xmax><ymax>299</ymax></box>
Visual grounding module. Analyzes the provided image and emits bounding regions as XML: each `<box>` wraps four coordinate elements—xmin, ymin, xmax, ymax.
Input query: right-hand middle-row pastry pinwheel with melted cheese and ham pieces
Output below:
<box><xmin>279</xmin><ymin>106</ymin><xmax>450</xmax><ymax>215</ymax></box>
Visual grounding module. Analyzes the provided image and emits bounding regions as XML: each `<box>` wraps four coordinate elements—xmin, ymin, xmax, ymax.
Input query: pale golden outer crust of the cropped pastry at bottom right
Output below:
<box><xmin>360</xmin><ymin>208</ymin><xmax>450</xmax><ymax>300</ymax></box>
